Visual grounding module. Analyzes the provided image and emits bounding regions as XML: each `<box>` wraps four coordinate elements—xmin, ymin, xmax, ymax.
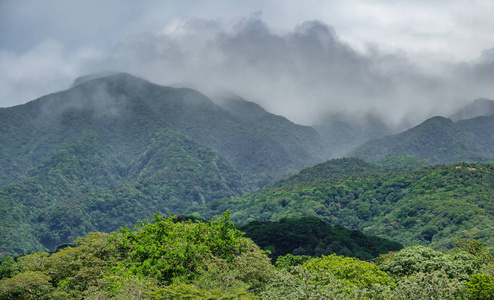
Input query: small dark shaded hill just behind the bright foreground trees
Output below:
<box><xmin>239</xmin><ymin>217</ymin><xmax>403</xmax><ymax>261</ymax></box>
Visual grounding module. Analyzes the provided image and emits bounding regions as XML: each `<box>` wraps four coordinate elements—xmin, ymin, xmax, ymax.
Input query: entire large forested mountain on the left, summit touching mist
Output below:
<box><xmin>0</xmin><ymin>73</ymin><xmax>332</xmax><ymax>255</ymax></box>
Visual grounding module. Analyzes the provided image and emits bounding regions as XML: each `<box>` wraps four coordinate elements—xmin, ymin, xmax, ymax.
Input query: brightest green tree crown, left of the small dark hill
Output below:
<box><xmin>111</xmin><ymin>213</ymin><xmax>248</xmax><ymax>282</ymax></box>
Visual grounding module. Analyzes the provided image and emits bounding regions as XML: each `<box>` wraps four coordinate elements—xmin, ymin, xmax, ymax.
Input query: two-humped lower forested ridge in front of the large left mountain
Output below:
<box><xmin>0</xmin><ymin>130</ymin><xmax>245</xmax><ymax>254</ymax></box>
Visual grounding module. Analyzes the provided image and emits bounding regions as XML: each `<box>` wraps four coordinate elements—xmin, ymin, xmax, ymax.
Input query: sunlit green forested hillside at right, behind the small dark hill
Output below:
<box><xmin>188</xmin><ymin>160</ymin><xmax>494</xmax><ymax>249</ymax></box>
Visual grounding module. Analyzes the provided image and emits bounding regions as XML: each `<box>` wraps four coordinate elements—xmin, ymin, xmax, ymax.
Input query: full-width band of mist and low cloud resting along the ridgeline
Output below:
<box><xmin>0</xmin><ymin>4</ymin><xmax>494</xmax><ymax>126</ymax></box>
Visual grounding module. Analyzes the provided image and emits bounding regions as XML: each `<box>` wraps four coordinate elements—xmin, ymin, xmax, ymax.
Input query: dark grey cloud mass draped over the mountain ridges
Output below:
<box><xmin>86</xmin><ymin>14</ymin><xmax>464</xmax><ymax>124</ymax></box>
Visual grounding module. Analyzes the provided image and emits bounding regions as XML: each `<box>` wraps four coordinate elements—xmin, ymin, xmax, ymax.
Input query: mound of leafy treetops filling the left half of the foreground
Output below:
<box><xmin>0</xmin><ymin>212</ymin><xmax>274</xmax><ymax>299</ymax></box>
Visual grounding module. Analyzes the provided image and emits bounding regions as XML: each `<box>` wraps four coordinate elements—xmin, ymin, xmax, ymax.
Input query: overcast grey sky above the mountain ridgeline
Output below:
<box><xmin>0</xmin><ymin>0</ymin><xmax>494</xmax><ymax>124</ymax></box>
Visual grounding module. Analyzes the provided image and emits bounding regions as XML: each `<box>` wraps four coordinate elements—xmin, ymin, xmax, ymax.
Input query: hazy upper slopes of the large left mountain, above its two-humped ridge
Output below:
<box><xmin>0</xmin><ymin>73</ymin><xmax>327</xmax><ymax>189</ymax></box>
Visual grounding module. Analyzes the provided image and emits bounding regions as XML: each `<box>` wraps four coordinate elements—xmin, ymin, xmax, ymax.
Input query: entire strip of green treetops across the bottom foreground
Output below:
<box><xmin>0</xmin><ymin>212</ymin><xmax>494</xmax><ymax>299</ymax></box>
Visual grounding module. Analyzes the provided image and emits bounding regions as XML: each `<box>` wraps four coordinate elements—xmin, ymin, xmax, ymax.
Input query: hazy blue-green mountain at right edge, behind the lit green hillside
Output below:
<box><xmin>348</xmin><ymin>116</ymin><xmax>494</xmax><ymax>164</ymax></box>
